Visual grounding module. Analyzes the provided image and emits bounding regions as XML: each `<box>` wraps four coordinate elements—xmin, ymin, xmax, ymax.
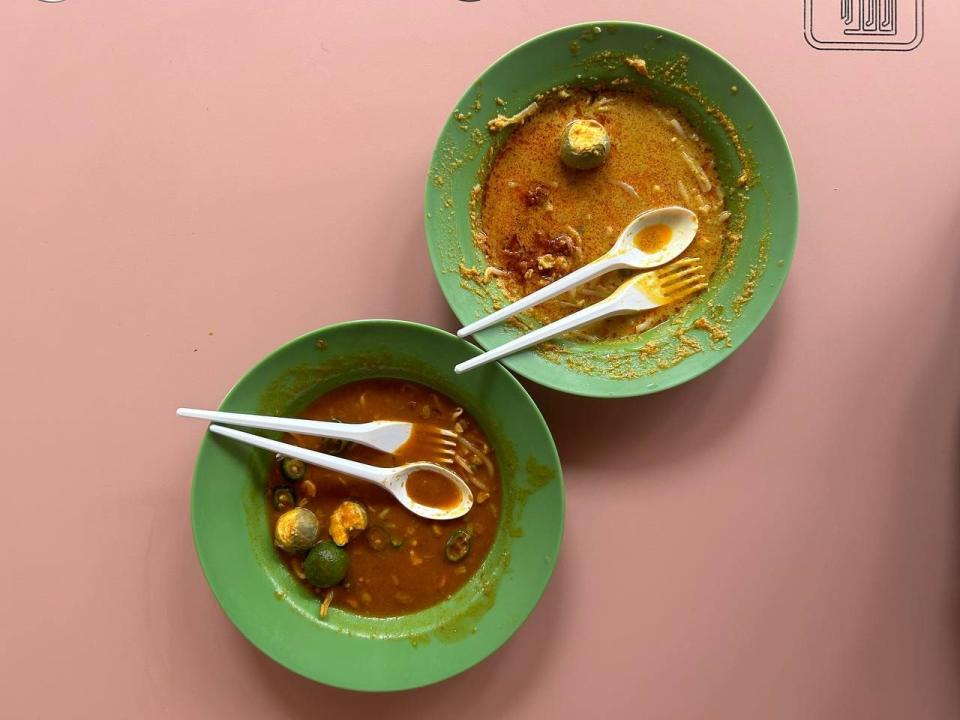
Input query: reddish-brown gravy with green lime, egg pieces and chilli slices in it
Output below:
<box><xmin>267</xmin><ymin>379</ymin><xmax>501</xmax><ymax>617</ymax></box>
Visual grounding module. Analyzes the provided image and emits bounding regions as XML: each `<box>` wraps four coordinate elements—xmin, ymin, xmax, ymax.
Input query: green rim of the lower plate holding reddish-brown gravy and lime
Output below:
<box><xmin>191</xmin><ymin>320</ymin><xmax>564</xmax><ymax>690</ymax></box>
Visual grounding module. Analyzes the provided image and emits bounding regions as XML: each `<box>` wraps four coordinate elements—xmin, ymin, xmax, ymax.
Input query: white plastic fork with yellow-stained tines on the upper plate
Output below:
<box><xmin>454</xmin><ymin>258</ymin><xmax>707</xmax><ymax>373</ymax></box>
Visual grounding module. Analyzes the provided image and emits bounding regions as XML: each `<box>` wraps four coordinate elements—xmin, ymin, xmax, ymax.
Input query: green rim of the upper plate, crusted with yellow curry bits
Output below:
<box><xmin>425</xmin><ymin>22</ymin><xmax>798</xmax><ymax>397</ymax></box>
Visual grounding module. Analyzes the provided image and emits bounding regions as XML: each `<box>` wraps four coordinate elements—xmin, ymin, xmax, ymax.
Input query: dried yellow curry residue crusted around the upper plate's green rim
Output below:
<box><xmin>432</xmin><ymin>49</ymin><xmax>771</xmax><ymax>380</ymax></box>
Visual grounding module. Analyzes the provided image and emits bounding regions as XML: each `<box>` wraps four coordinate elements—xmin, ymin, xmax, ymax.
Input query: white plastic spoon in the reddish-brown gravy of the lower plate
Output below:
<box><xmin>210</xmin><ymin>425</ymin><xmax>473</xmax><ymax>520</ymax></box>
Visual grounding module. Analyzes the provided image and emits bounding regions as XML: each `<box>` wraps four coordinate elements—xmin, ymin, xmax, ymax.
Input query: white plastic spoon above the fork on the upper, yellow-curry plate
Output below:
<box><xmin>457</xmin><ymin>205</ymin><xmax>699</xmax><ymax>337</ymax></box>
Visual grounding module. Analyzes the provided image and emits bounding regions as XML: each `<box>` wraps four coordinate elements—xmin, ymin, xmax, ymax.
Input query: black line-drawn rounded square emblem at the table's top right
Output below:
<box><xmin>803</xmin><ymin>0</ymin><xmax>923</xmax><ymax>51</ymax></box>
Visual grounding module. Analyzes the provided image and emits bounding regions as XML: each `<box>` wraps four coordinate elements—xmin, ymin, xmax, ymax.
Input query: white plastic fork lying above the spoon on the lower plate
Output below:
<box><xmin>177</xmin><ymin>408</ymin><xmax>457</xmax><ymax>463</ymax></box>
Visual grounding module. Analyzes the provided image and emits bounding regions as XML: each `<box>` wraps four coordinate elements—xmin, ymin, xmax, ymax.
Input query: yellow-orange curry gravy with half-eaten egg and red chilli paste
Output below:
<box><xmin>475</xmin><ymin>88</ymin><xmax>730</xmax><ymax>340</ymax></box>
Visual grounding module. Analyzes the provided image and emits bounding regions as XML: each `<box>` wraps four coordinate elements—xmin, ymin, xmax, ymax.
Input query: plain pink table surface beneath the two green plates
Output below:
<box><xmin>0</xmin><ymin>0</ymin><xmax>960</xmax><ymax>720</ymax></box>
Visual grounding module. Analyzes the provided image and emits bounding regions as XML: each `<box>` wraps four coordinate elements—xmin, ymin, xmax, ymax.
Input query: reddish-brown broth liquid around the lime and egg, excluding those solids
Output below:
<box><xmin>267</xmin><ymin>379</ymin><xmax>501</xmax><ymax>616</ymax></box>
